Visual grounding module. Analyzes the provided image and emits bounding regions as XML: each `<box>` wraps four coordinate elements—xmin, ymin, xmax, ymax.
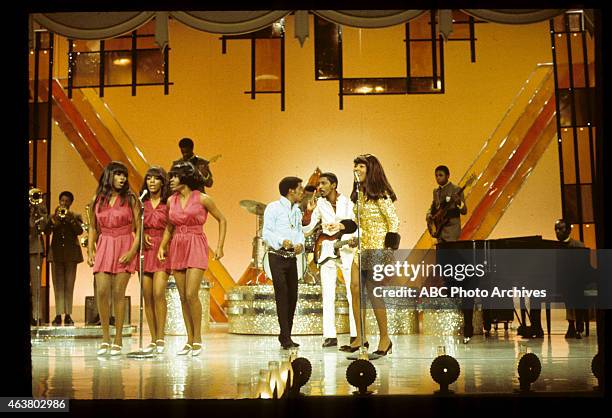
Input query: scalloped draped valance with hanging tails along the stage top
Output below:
<box><xmin>32</xmin><ymin>9</ymin><xmax>568</xmax><ymax>49</ymax></box>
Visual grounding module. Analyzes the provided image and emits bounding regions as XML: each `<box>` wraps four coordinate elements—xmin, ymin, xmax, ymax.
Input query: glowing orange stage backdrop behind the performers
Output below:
<box><xmin>44</xmin><ymin>17</ymin><xmax>561</xmax><ymax>318</ymax></box>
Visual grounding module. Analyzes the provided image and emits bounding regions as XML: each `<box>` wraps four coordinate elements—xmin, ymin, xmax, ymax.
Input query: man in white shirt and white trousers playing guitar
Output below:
<box><xmin>302</xmin><ymin>173</ymin><xmax>357</xmax><ymax>348</ymax></box>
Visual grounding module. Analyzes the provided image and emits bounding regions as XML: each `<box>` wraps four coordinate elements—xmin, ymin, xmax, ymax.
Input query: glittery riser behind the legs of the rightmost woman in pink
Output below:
<box><xmin>164</xmin><ymin>276</ymin><xmax>211</xmax><ymax>335</ymax></box>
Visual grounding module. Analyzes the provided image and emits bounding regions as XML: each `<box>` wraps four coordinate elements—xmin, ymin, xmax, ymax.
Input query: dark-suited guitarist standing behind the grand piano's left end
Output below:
<box><xmin>426</xmin><ymin>165</ymin><xmax>474</xmax><ymax>344</ymax></box>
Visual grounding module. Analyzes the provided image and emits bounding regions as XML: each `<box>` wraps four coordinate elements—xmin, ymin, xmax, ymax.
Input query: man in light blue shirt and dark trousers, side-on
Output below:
<box><xmin>263</xmin><ymin>177</ymin><xmax>304</xmax><ymax>349</ymax></box>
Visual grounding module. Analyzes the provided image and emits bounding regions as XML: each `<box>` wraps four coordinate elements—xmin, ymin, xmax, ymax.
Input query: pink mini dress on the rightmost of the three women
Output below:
<box><xmin>168</xmin><ymin>190</ymin><xmax>208</xmax><ymax>270</ymax></box>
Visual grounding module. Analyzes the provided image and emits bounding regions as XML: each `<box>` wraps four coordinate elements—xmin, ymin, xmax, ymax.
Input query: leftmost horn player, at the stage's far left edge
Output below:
<box><xmin>28</xmin><ymin>185</ymin><xmax>49</xmax><ymax>326</ymax></box>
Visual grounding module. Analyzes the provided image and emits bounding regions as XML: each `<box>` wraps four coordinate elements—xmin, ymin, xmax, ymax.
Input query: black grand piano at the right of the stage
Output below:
<box><xmin>436</xmin><ymin>235</ymin><xmax>597</xmax><ymax>336</ymax></box>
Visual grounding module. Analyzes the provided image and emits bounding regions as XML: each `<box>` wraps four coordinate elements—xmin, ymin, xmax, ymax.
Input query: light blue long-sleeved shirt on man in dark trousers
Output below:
<box><xmin>263</xmin><ymin>196</ymin><xmax>304</xmax><ymax>250</ymax></box>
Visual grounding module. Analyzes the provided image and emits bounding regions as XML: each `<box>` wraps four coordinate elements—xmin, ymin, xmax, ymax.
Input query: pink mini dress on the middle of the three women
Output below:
<box><xmin>143</xmin><ymin>199</ymin><xmax>170</xmax><ymax>273</ymax></box>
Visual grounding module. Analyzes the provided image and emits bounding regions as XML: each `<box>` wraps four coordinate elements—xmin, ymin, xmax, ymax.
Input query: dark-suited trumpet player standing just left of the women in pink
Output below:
<box><xmin>46</xmin><ymin>191</ymin><xmax>83</xmax><ymax>326</ymax></box>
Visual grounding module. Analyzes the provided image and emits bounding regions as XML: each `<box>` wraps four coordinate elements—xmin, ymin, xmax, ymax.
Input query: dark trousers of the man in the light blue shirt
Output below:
<box><xmin>269</xmin><ymin>253</ymin><xmax>298</xmax><ymax>345</ymax></box>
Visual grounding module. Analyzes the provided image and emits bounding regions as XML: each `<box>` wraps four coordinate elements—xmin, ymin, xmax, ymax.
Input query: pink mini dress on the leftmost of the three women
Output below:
<box><xmin>93</xmin><ymin>196</ymin><xmax>138</xmax><ymax>274</ymax></box>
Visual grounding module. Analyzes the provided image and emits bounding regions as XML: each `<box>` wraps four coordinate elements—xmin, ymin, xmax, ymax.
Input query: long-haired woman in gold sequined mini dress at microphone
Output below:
<box><xmin>340</xmin><ymin>154</ymin><xmax>400</xmax><ymax>356</ymax></box>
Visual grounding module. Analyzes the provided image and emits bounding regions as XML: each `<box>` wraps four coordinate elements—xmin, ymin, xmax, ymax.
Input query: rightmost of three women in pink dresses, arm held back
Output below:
<box><xmin>158</xmin><ymin>161</ymin><xmax>226</xmax><ymax>356</ymax></box>
